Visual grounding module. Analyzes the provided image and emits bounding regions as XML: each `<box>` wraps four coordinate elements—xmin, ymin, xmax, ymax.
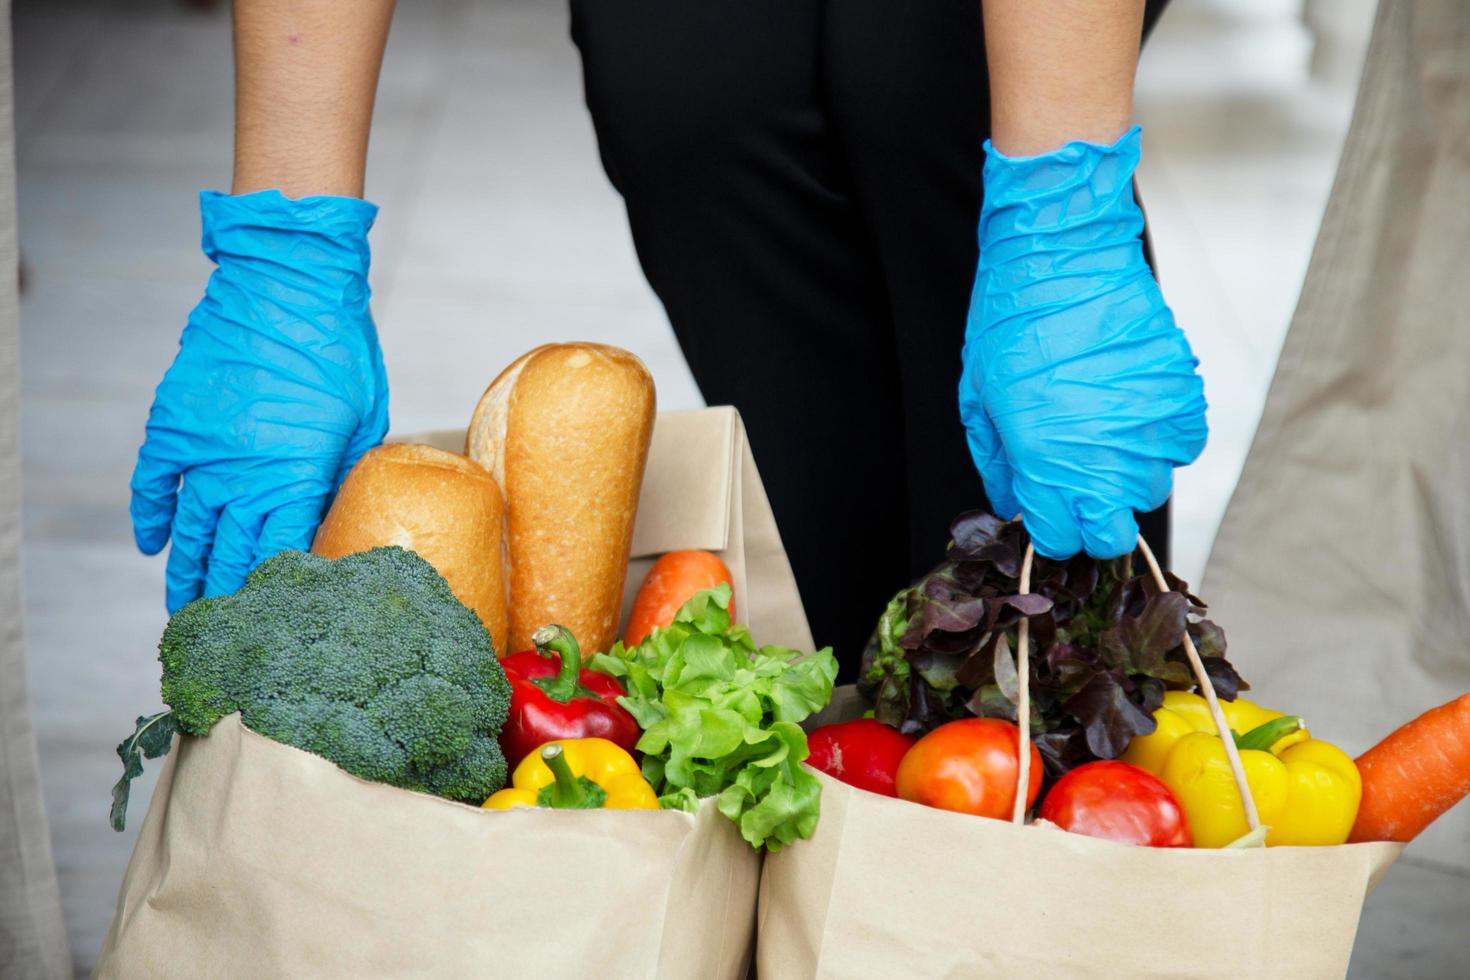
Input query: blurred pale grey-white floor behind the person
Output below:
<box><xmin>15</xmin><ymin>0</ymin><xmax>1470</xmax><ymax>977</ymax></box>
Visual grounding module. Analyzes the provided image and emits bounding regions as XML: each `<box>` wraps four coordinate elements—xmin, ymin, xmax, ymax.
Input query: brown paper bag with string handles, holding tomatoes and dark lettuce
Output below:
<box><xmin>757</xmin><ymin>540</ymin><xmax>1402</xmax><ymax>980</ymax></box>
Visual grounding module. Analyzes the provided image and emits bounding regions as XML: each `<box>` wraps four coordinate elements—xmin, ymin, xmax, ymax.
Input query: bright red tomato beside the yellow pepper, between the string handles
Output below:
<box><xmin>1039</xmin><ymin>760</ymin><xmax>1194</xmax><ymax>848</ymax></box>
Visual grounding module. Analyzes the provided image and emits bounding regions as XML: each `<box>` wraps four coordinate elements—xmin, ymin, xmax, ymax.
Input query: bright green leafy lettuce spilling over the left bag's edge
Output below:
<box><xmin>592</xmin><ymin>585</ymin><xmax>836</xmax><ymax>851</ymax></box>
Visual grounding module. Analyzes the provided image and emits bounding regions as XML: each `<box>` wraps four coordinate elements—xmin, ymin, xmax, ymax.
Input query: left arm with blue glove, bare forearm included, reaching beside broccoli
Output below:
<box><xmin>129</xmin><ymin>0</ymin><xmax>392</xmax><ymax>613</ymax></box>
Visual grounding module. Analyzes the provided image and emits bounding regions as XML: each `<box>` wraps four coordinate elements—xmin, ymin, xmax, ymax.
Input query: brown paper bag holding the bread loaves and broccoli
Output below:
<box><xmin>97</xmin><ymin>408</ymin><xmax>810</xmax><ymax>979</ymax></box>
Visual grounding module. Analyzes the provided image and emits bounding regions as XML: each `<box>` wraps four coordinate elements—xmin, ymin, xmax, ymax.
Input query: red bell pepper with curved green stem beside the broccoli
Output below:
<box><xmin>500</xmin><ymin>626</ymin><xmax>642</xmax><ymax>765</ymax></box>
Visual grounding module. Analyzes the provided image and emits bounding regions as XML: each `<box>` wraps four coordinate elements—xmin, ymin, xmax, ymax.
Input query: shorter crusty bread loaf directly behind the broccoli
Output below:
<box><xmin>312</xmin><ymin>444</ymin><xmax>509</xmax><ymax>655</ymax></box>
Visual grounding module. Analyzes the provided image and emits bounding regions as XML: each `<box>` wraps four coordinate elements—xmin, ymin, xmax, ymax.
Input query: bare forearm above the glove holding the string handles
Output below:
<box><xmin>982</xmin><ymin>0</ymin><xmax>1144</xmax><ymax>156</ymax></box>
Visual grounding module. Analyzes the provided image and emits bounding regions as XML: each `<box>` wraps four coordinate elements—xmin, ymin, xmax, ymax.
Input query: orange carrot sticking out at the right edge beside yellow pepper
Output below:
<box><xmin>1348</xmin><ymin>693</ymin><xmax>1470</xmax><ymax>843</ymax></box>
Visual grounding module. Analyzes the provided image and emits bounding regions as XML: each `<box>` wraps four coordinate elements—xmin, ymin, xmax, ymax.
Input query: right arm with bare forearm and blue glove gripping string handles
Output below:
<box><xmin>960</xmin><ymin>0</ymin><xmax>1208</xmax><ymax>558</ymax></box>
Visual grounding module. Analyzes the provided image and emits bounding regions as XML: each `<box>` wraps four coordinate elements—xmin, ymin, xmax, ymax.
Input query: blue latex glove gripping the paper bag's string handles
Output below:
<box><xmin>960</xmin><ymin>126</ymin><xmax>1207</xmax><ymax>558</ymax></box>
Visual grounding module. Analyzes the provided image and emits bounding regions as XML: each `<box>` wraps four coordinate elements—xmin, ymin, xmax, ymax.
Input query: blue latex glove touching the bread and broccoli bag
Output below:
<box><xmin>131</xmin><ymin>191</ymin><xmax>388</xmax><ymax>613</ymax></box>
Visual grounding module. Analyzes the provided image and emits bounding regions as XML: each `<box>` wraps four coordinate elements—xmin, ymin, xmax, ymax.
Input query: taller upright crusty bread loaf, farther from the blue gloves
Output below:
<box><xmin>465</xmin><ymin>344</ymin><xmax>654</xmax><ymax>652</ymax></box>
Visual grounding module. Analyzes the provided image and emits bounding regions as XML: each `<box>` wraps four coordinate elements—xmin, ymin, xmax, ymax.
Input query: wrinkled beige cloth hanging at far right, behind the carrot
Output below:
<box><xmin>1204</xmin><ymin>0</ymin><xmax>1470</xmax><ymax>875</ymax></box>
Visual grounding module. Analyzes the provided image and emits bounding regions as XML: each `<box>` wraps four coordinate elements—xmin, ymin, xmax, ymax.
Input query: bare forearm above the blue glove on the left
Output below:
<box><xmin>234</xmin><ymin>0</ymin><xmax>394</xmax><ymax>197</ymax></box>
